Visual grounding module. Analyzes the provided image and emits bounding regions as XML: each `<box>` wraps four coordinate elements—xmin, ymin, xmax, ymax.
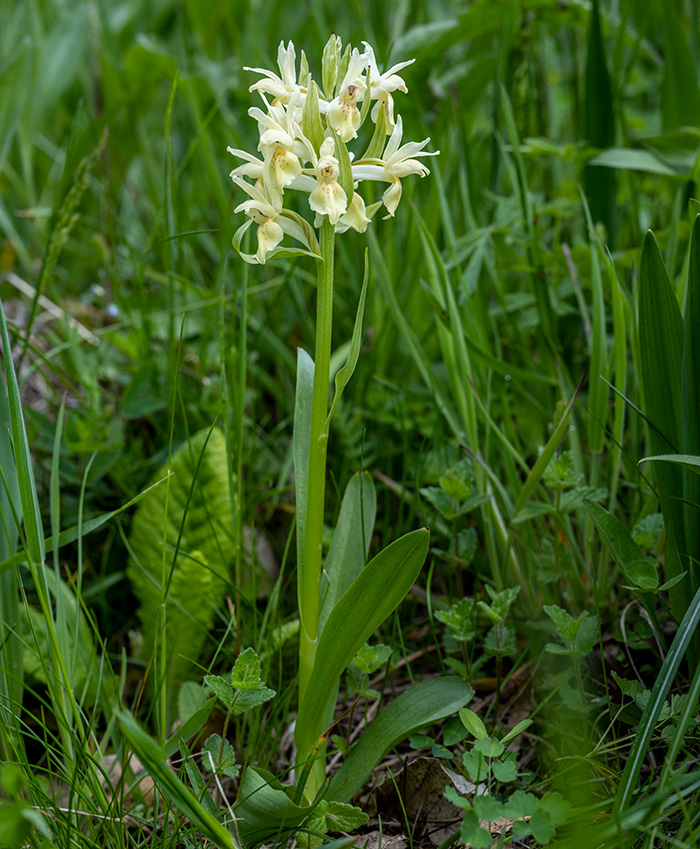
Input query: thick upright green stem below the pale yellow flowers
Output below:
<box><xmin>297</xmin><ymin>217</ymin><xmax>335</xmax><ymax>784</ymax></box>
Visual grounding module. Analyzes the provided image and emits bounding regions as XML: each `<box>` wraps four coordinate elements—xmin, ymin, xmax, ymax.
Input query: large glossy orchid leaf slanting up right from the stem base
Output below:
<box><xmin>295</xmin><ymin>528</ymin><xmax>430</xmax><ymax>764</ymax></box>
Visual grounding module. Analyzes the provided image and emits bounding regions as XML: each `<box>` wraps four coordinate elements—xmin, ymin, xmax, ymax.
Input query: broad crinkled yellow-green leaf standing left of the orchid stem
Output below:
<box><xmin>126</xmin><ymin>428</ymin><xmax>235</xmax><ymax>707</ymax></box>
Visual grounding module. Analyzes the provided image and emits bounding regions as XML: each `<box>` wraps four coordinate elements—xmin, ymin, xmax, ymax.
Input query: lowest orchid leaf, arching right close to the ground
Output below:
<box><xmin>328</xmin><ymin>678</ymin><xmax>474</xmax><ymax>802</ymax></box>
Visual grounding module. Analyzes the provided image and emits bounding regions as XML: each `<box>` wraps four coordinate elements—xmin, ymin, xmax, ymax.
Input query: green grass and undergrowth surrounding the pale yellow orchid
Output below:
<box><xmin>0</xmin><ymin>0</ymin><xmax>700</xmax><ymax>847</ymax></box>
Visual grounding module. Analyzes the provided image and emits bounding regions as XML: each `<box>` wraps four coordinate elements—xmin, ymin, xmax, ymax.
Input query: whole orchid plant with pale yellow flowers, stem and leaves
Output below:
<box><xmin>229</xmin><ymin>35</ymin><xmax>467</xmax><ymax>823</ymax></box>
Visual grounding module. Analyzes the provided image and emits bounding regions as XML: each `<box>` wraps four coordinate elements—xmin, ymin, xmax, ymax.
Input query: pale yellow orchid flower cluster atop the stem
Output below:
<box><xmin>228</xmin><ymin>35</ymin><xmax>437</xmax><ymax>263</ymax></box>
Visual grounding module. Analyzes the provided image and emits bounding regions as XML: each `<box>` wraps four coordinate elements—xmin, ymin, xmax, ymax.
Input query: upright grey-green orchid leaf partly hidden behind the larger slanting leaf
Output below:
<box><xmin>318</xmin><ymin>472</ymin><xmax>377</xmax><ymax>633</ymax></box>
